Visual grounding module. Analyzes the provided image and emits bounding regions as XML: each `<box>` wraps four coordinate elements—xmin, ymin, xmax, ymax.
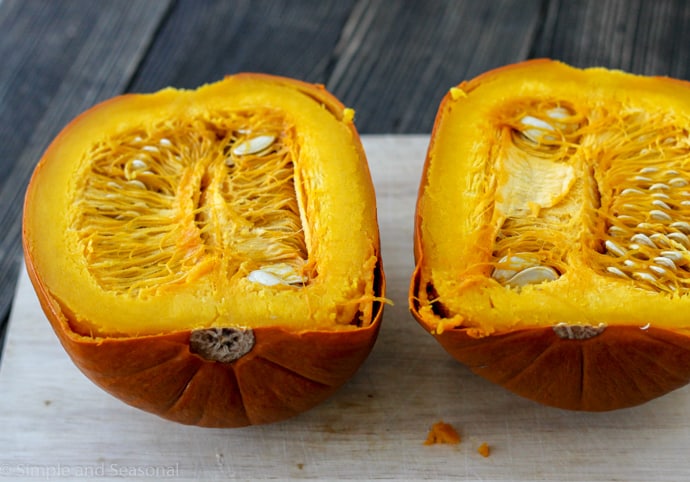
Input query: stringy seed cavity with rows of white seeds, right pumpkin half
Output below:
<box><xmin>484</xmin><ymin>99</ymin><xmax>690</xmax><ymax>294</ymax></box>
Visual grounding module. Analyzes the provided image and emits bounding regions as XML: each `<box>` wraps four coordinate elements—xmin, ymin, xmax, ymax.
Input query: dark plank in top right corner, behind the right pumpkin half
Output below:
<box><xmin>530</xmin><ymin>0</ymin><xmax>690</xmax><ymax>79</ymax></box>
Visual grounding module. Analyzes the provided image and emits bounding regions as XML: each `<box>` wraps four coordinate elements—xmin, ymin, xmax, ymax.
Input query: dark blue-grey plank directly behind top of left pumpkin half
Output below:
<box><xmin>128</xmin><ymin>0</ymin><xmax>353</xmax><ymax>92</ymax></box>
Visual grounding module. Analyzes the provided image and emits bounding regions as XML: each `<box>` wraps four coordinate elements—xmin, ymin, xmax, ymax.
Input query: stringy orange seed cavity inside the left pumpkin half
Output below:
<box><xmin>71</xmin><ymin>110</ymin><xmax>308</xmax><ymax>296</ymax></box>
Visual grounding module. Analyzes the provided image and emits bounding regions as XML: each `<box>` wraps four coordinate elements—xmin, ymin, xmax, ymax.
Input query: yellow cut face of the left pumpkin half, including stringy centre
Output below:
<box><xmin>25</xmin><ymin>77</ymin><xmax>378</xmax><ymax>336</ymax></box>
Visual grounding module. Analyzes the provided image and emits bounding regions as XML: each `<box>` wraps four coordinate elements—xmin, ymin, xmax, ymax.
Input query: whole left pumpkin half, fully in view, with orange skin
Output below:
<box><xmin>23</xmin><ymin>74</ymin><xmax>384</xmax><ymax>427</ymax></box>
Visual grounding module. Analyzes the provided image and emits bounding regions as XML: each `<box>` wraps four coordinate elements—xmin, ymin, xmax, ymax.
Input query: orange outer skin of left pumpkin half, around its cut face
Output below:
<box><xmin>23</xmin><ymin>74</ymin><xmax>385</xmax><ymax>428</ymax></box>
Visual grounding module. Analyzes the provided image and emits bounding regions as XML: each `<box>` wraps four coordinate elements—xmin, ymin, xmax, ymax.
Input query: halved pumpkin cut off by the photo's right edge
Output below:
<box><xmin>410</xmin><ymin>59</ymin><xmax>690</xmax><ymax>411</ymax></box>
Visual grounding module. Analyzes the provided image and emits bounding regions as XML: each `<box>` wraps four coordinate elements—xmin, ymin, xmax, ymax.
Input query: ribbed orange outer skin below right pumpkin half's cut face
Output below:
<box><xmin>411</xmin><ymin>286</ymin><xmax>690</xmax><ymax>412</ymax></box>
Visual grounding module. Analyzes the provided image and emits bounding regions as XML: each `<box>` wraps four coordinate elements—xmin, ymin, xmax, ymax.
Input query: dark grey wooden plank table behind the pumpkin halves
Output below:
<box><xmin>0</xmin><ymin>0</ymin><xmax>690</xmax><ymax>354</ymax></box>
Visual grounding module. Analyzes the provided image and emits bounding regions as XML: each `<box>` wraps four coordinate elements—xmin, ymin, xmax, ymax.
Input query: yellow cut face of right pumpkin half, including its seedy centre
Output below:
<box><xmin>420</xmin><ymin>64</ymin><xmax>690</xmax><ymax>336</ymax></box>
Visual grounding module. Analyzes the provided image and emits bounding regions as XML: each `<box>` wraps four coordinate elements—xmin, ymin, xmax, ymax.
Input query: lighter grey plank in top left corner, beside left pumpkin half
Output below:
<box><xmin>0</xmin><ymin>0</ymin><xmax>168</xmax><ymax>338</ymax></box>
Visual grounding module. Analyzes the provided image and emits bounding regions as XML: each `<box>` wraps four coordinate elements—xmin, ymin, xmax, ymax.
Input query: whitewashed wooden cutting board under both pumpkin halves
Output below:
<box><xmin>0</xmin><ymin>135</ymin><xmax>690</xmax><ymax>482</ymax></box>
